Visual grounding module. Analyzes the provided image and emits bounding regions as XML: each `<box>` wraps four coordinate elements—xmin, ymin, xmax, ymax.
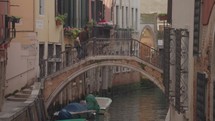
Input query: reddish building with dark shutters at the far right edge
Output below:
<box><xmin>196</xmin><ymin>0</ymin><xmax>215</xmax><ymax>121</ymax></box>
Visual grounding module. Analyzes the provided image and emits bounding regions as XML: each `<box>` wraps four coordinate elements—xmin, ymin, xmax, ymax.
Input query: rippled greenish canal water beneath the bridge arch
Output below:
<box><xmin>108</xmin><ymin>83</ymin><xmax>168</xmax><ymax>121</ymax></box>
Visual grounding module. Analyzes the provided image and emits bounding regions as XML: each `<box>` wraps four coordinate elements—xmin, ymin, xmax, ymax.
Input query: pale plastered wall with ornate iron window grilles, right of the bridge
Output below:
<box><xmin>164</xmin><ymin>0</ymin><xmax>194</xmax><ymax>121</ymax></box>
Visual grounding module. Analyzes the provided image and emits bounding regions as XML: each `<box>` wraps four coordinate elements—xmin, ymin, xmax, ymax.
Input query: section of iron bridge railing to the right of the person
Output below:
<box><xmin>88</xmin><ymin>38</ymin><xmax>162</xmax><ymax>68</ymax></box>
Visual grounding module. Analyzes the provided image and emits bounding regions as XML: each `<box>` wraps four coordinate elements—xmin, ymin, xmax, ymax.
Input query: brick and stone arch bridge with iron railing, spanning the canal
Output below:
<box><xmin>40</xmin><ymin>38</ymin><xmax>164</xmax><ymax>115</ymax></box>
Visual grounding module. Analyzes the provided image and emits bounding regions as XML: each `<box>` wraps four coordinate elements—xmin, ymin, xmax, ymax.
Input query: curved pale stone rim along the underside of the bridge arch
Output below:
<box><xmin>45</xmin><ymin>61</ymin><xmax>164</xmax><ymax>109</ymax></box>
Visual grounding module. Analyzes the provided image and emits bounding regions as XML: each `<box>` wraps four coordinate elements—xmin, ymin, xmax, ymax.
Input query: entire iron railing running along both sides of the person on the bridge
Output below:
<box><xmin>40</xmin><ymin>38</ymin><xmax>162</xmax><ymax>79</ymax></box>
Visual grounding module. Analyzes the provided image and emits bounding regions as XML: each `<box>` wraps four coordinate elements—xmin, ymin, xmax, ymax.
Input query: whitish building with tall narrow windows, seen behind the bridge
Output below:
<box><xmin>111</xmin><ymin>0</ymin><xmax>140</xmax><ymax>86</ymax></box>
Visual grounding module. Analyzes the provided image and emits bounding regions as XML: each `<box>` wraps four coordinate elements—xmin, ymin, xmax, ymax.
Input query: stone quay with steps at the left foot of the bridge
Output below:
<box><xmin>0</xmin><ymin>82</ymin><xmax>46</xmax><ymax>121</ymax></box>
